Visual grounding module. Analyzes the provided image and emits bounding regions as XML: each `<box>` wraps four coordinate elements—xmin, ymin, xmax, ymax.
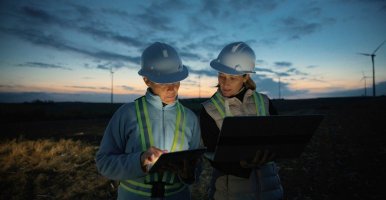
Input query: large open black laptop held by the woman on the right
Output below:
<box><xmin>212</xmin><ymin>115</ymin><xmax>324</xmax><ymax>162</ymax></box>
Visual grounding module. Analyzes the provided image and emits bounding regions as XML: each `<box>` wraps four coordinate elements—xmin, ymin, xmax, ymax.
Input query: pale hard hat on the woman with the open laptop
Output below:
<box><xmin>210</xmin><ymin>42</ymin><xmax>256</xmax><ymax>75</ymax></box>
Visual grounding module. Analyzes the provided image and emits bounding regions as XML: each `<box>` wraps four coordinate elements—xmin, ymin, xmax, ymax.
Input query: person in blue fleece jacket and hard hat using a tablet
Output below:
<box><xmin>96</xmin><ymin>42</ymin><xmax>200</xmax><ymax>200</ymax></box>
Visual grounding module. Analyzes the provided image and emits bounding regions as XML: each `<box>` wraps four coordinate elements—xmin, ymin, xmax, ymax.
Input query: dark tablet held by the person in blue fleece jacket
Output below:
<box><xmin>149</xmin><ymin>148</ymin><xmax>206</xmax><ymax>173</ymax></box>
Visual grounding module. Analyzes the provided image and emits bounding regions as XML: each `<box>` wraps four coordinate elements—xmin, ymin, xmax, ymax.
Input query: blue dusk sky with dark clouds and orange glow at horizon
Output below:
<box><xmin>0</xmin><ymin>0</ymin><xmax>386</xmax><ymax>102</ymax></box>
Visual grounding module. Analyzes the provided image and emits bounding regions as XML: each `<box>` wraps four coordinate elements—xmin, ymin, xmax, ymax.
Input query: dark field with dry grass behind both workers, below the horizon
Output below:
<box><xmin>0</xmin><ymin>97</ymin><xmax>386</xmax><ymax>200</ymax></box>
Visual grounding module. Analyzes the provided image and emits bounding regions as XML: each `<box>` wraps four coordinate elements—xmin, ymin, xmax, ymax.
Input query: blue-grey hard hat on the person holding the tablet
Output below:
<box><xmin>138</xmin><ymin>42</ymin><xmax>189</xmax><ymax>83</ymax></box>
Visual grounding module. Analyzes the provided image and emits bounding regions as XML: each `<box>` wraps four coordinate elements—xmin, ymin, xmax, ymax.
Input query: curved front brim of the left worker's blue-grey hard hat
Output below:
<box><xmin>138</xmin><ymin>65</ymin><xmax>189</xmax><ymax>84</ymax></box>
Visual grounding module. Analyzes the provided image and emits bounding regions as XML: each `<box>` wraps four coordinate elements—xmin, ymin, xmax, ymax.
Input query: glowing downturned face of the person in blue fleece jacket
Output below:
<box><xmin>143</xmin><ymin>77</ymin><xmax>180</xmax><ymax>104</ymax></box>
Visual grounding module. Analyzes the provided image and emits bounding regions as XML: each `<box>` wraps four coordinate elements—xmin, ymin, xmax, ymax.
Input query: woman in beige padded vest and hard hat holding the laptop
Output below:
<box><xmin>200</xmin><ymin>42</ymin><xmax>283</xmax><ymax>200</ymax></box>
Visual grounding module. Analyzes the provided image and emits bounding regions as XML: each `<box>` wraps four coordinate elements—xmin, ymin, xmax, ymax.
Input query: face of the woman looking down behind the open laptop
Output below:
<box><xmin>218</xmin><ymin>73</ymin><xmax>249</xmax><ymax>97</ymax></box>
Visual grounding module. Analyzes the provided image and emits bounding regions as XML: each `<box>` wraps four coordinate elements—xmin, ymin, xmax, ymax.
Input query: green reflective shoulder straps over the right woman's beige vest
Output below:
<box><xmin>210</xmin><ymin>92</ymin><xmax>266</xmax><ymax>118</ymax></box>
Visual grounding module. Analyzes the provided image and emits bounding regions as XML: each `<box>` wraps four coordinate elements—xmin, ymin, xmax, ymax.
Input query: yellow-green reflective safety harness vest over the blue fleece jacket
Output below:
<box><xmin>120</xmin><ymin>96</ymin><xmax>186</xmax><ymax>197</ymax></box>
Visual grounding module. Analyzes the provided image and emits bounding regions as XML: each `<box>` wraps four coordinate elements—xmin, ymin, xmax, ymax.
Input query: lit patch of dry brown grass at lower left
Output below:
<box><xmin>0</xmin><ymin>139</ymin><xmax>115</xmax><ymax>199</ymax></box>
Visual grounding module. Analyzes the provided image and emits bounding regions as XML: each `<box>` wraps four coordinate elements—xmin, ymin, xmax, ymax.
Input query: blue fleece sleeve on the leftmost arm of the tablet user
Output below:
<box><xmin>96</xmin><ymin>107</ymin><xmax>146</xmax><ymax>180</ymax></box>
